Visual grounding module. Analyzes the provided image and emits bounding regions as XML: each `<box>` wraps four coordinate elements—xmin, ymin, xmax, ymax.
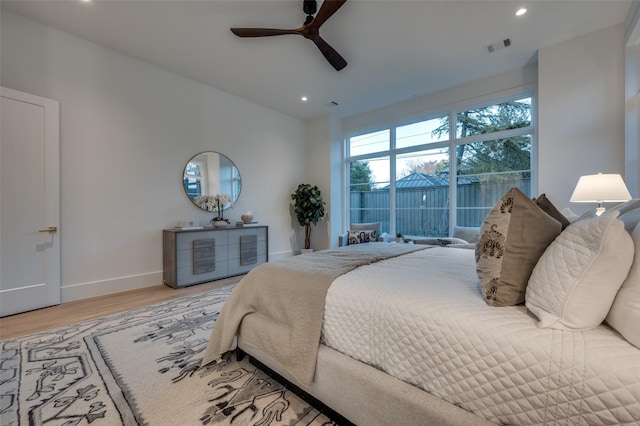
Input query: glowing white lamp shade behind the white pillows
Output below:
<box><xmin>571</xmin><ymin>173</ymin><xmax>631</xmax><ymax>203</ymax></box>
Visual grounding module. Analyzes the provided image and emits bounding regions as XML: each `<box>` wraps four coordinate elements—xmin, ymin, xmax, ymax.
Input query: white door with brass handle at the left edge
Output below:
<box><xmin>0</xmin><ymin>87</ymin><xmax>60</xmax><ymax>316</ymax></box>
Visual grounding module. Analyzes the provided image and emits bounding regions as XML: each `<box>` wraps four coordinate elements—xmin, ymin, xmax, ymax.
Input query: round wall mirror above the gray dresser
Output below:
<box><xmin>182</xmin><ymin>151</ymin><xmax>242</xmax><ymax>211</ymax></box>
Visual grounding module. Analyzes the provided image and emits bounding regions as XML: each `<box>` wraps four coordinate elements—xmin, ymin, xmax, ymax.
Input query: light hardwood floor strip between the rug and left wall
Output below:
<box><xmin>0</xmin><ymin>276</ymin><xmax>242</xmax><ymax>340</ymax></box>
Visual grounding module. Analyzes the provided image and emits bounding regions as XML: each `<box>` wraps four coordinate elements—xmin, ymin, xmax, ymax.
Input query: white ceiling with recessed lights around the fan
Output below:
<box><xmin>2</xmin><ymin>0</ymin><xmax>631</xmax><ymax>119</ymax></box>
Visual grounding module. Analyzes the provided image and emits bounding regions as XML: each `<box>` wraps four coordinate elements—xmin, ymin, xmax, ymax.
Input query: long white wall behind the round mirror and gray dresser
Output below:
<box><xmin>0</xmin><ymin>10</ymin><xmax>306</xmax><ymax>301</ymax></box>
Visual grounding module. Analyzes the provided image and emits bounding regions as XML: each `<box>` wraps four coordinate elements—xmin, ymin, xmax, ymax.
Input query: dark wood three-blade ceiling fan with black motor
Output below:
<box><xmin>231</xmin><ymin>0</ymin><xmax>347</xmax><ymax>71</ymax></box>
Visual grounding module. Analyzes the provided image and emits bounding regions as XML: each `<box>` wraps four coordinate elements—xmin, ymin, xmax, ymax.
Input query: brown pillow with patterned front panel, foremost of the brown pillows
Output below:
<box><xmin>476</xmin><ymin>188</ymin><xmax>562</xmax><ymax>306</ymax></box>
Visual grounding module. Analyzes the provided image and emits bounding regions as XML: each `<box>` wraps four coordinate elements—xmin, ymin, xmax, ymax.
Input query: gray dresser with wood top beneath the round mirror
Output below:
<box><xmin>162</xmin><ymin>226</ymin><xmax>269</xmax><ymax>288</ymax></box>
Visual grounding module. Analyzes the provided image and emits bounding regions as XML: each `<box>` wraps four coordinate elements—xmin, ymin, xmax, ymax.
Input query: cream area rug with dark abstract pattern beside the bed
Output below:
<box><xmin>0</xmin><ymin>286</ymin><xmax>335</xmax><ymax>426</ymax></box>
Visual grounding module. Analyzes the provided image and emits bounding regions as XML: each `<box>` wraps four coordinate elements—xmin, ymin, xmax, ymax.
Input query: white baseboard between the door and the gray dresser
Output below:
<box><xmin>60</xmin><ymin>271</ymin><xmax>162</xmax><ymax>303</ymax></box>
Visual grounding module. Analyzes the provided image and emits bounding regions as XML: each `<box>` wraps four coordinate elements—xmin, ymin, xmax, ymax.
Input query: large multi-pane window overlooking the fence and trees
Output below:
<box><xmin>346</xmin><ymin>96</ymin><xmax>534</xmax><ymax>237</ymax></box>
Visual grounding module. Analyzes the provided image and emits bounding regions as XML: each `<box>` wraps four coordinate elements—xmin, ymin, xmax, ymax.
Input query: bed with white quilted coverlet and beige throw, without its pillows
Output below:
<box><xmin>203</xmin><ymin>195</ymin><xmax>640</xmax><ymax>425</ymax></box>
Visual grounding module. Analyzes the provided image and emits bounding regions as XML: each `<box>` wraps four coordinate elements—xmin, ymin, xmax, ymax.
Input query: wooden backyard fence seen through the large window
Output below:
<box><xmin>350</xmin><ymin>179</ymin><xmax>531</xmax><ymax>237</ymax></box>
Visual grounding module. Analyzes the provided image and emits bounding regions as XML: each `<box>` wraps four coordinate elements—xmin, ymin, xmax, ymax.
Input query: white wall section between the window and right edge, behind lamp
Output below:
<box><xmin>538</xmin><ymin>24</ymin><xmax>625</xmax><ymax>213</ymax></box>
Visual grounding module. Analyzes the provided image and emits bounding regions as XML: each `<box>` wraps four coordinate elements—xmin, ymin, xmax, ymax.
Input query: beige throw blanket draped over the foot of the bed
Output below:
<box><xmin>202</xmin><ymin>243</ymin><xmax>429</xmax><ymax>385</ymax></box>
